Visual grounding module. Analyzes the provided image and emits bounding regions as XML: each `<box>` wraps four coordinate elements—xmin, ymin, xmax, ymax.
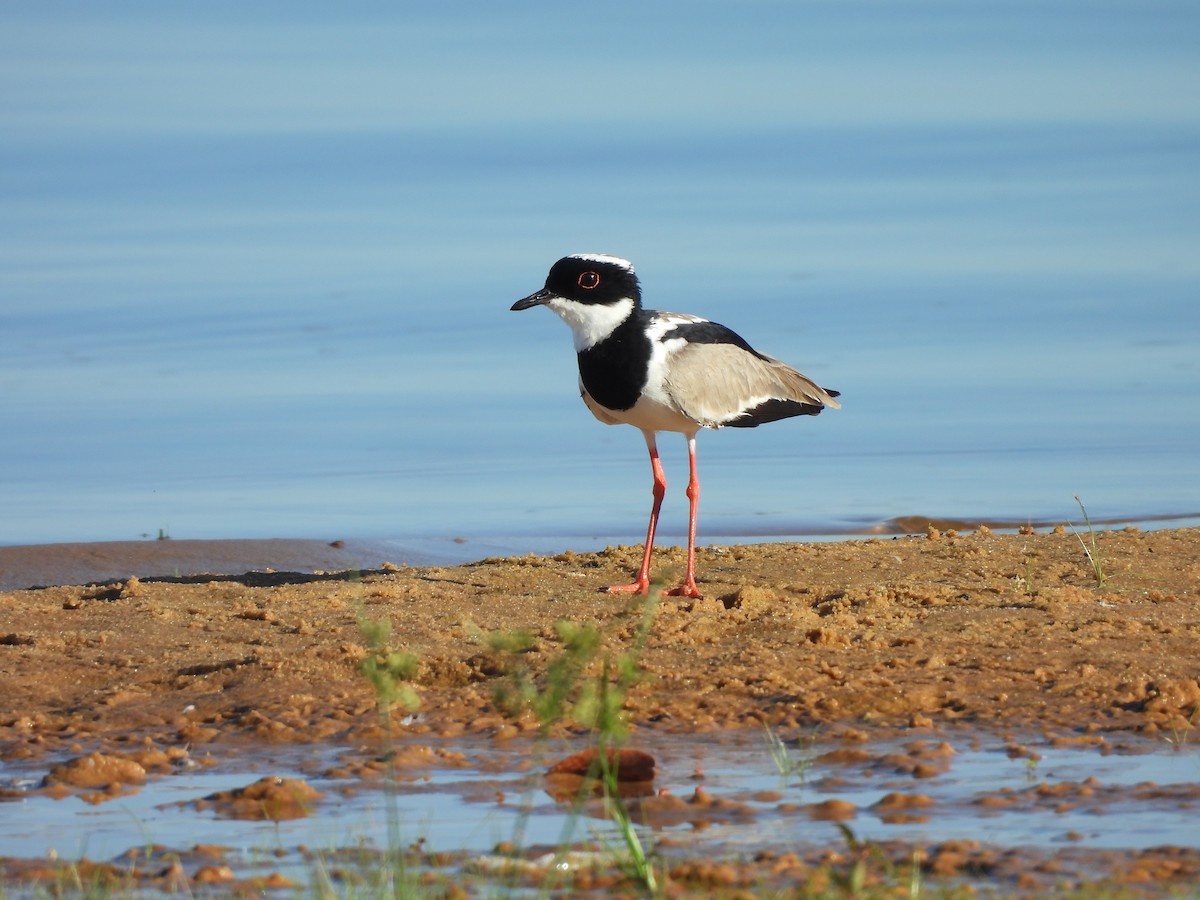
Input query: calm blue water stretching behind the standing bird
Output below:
<box><xmin>0</xmin><ymin>0</ymin><xmax>1200</xmax><ymax>548</ymax></box>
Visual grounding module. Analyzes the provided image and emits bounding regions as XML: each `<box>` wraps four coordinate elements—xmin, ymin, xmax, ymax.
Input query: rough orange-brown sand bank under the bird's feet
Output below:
<box><xmin>0</xmin><ymin>528</ymin><xmax>1200</xmax><ymax>884</ymax></box>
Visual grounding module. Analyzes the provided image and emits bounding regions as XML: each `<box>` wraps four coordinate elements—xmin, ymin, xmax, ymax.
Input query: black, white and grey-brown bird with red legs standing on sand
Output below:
<box><xmin>511</xmin><ymin>253</ymin><xmax>840</xmax><ymax>599</ymax></box>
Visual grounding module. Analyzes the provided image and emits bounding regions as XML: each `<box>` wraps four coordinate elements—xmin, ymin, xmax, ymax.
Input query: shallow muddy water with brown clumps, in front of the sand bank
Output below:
<box><xmin>0</xmin><ymin>734</ymin><xmax>1200</xmax><ymax>881</ymax></box>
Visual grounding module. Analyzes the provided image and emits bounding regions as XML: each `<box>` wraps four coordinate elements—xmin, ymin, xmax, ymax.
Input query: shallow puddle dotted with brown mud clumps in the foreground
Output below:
<box><xmin>0</xmin><ymin>732</ymin><xmax>1200</xmax><ymax>884</ymax></box>
